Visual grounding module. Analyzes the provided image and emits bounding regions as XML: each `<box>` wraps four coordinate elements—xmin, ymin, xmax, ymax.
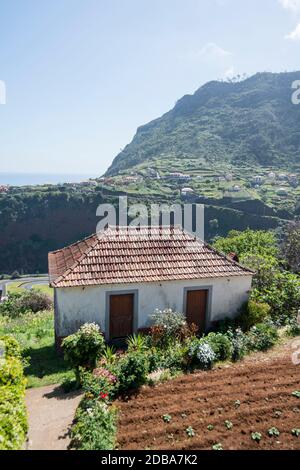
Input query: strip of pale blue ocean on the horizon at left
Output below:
<box><xmin>0</xmin><ymin>172</ymin><xmax>100</xmax><ymax>186</ymax></box>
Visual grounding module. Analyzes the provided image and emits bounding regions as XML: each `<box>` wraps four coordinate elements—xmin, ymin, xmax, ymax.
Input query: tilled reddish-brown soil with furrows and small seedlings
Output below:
<box><xmin>117</xmin><ymin>351</ymin><xmax>300</xmax><ymax>450</ymax></box>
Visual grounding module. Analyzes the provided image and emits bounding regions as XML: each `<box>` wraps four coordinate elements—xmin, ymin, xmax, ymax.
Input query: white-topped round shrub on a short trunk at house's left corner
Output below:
<box><xmin>62</xmin><ymin>323</ymin><xmax>105</xmax><ymax>384</ymax></box>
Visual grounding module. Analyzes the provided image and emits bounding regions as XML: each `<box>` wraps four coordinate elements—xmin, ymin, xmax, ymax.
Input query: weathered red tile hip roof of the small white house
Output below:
<box><xmin>49</xmin><ymin>227</ymin><xmax>253</xmax><ymax>287</ymax></box>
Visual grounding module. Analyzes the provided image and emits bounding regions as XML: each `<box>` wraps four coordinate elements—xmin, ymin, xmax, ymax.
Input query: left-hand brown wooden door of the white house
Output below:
<box><xmin>109</xmin><ymin>294</ymin><xmax>134</xmax><ymax>340</ymax></box>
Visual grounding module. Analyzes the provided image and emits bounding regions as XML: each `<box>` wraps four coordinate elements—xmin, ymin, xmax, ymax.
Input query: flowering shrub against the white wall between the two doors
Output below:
<box><xmin>150</xmin><ymin>309</ymin><xmax>187</xmax><ymax>347</ymax></box>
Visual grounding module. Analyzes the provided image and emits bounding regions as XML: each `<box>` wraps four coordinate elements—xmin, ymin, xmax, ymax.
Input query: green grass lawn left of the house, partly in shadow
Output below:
<box><xmin>0</xmin><ymin>312</ymin><xmax>74</xmax><ymax>388</ymax></box>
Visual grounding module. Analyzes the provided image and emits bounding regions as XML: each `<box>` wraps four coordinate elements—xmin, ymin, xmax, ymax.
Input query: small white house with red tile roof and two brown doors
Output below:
<box><xmin>49</xmin><ymin>227</ymin><xmax>253</xmax><ymax>344</ymax></box>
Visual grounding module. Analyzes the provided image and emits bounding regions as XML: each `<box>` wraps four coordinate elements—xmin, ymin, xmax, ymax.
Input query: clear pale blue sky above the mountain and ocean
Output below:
<box><xmin>0</xmin><ymin>0</ymin><xmax>300</xmax><ymax>176</ymax></box>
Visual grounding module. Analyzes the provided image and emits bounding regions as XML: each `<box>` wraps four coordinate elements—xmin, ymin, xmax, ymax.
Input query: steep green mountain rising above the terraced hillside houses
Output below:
<box><xmin>106</xmin><ymin>72</ymin><xmax>300</xmax><ymax>176</ymax></box>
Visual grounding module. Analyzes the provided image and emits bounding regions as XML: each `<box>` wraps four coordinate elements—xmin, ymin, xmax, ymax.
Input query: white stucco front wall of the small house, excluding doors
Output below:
<box><xmin>55</xmin><ymin>276</ymin><xmax>252</xmax><ymax>337</ymax></box>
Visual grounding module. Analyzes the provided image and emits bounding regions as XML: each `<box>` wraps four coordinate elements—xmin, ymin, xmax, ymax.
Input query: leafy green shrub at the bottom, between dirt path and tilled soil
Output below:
<box><xmin>70</xmin><ymin>397</ymin><xmax>117</xmax><ymax>450</ymax></box>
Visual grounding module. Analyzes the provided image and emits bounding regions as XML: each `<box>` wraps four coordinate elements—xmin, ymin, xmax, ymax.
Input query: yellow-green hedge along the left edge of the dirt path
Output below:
<box><xmin>0</xmin><ymin>335</ymin><xmax>28</xmax><ymax>450</ymax></box>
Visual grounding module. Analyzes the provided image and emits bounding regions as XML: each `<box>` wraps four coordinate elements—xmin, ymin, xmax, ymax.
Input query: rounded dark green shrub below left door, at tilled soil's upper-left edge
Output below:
<box><xmin>116</xmin><ymin>352</ymin><xmax>149</xmax><ymax>393</ymax></box>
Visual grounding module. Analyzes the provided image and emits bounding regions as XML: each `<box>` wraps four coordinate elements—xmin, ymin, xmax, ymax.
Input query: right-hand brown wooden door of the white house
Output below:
<box><xmin>186</xmin><ymin>290</ymin><xmax>208</xmax><ymax>333</ymax></box>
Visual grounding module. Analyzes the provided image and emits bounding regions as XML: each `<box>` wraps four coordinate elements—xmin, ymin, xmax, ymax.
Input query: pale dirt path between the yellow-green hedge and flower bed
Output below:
<box><xmin>26</xmin><ymin>385</ymin><xmax>81</xmax><ymax>450</ymax></box>
